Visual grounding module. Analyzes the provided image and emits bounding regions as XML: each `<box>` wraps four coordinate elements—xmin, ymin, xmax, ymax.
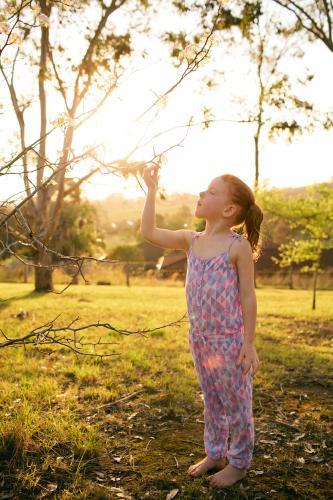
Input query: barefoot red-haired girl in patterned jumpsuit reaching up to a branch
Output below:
<box><xmin>140</xmin><ymin>166</ymin><xmax>263</xmax><ymax>488</ymax></box>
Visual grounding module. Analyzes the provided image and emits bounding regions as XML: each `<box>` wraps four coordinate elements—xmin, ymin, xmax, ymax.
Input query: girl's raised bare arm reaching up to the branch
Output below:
<box><xmin>140</xmin><ymin>166</ymin><xmax>191</xmax><ymax>251</ymax></box>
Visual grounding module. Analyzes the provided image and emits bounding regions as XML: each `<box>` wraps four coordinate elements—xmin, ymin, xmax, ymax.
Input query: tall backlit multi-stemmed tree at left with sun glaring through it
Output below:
<box><xmin>0</xmin><ymin>0</ymin><xmax>219</xmax><ymax>291</ymax></box>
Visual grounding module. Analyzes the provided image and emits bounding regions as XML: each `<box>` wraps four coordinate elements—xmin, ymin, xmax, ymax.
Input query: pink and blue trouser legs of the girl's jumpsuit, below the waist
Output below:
<box><xmin>189</xmin><ymin>332</ymin><xmax>254</xmax><ymax>469</ymax></box>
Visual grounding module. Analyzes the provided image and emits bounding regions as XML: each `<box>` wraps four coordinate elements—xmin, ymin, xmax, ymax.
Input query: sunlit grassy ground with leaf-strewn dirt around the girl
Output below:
<box><xmin>0</xmin><ymin>283</ymin><xmax>333</xmax><ymax>500</ymax></box>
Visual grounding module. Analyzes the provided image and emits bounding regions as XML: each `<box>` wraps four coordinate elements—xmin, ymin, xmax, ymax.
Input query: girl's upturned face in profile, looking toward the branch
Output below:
<box><xmin>194</xmin><ymin>177</ymin><xmax>236</xmax><ymax>219</ymax></box>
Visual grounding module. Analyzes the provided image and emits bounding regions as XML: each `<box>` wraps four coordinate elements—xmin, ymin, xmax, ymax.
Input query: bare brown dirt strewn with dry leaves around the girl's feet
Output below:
<box><xmin>73</xmin><ymin>383</ymin><xmax>333</xmax><ymax>500</ymax></box>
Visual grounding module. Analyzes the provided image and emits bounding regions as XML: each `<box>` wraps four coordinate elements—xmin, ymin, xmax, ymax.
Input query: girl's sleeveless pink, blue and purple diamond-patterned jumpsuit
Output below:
<box><xmin>185</xmin><ymin>232</ymin><xmax>254</xmax><ymax>469</ymax></box>
